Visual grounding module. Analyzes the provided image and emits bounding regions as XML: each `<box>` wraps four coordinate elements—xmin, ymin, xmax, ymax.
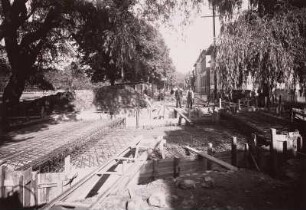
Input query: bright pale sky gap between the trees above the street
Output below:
<box><xmin>160</xmin><ymin>0</ymin><xmax>246</xmax><ymax>74</ymax></box>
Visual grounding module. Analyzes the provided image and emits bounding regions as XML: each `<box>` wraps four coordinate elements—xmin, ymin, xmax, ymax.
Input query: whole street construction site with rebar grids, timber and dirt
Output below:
<box><xmin>0</xmin><ymin>88</ymin><xmax>306</xmax><ymax>210</ymax></box>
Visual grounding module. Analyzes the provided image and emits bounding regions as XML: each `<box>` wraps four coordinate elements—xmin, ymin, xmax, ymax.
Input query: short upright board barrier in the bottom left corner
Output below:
<box><xmin>0</xmin><ymin>156</ymin><xmax>75</xmax><ymax>209</ymax></box>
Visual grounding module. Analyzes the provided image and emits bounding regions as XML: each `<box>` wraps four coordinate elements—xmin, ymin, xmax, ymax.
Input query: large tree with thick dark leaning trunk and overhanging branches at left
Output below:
<box><xmin>0</xmin><ymin>0</ymin><xmax>240</xmax><ymax>130</ymax></box>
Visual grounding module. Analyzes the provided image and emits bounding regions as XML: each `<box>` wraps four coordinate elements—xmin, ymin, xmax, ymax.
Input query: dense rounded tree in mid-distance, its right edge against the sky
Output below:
<box><xmin>75</xmin><ymin>5</ymin><xmax>173</xmax><ymax>85</ymax></box>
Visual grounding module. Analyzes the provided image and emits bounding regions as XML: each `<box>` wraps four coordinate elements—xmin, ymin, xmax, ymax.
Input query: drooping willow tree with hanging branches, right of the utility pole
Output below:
<box><xmin>216</xmin><ymin>7</ymin><xmax>306</xmax><ymax>96</ymax></box>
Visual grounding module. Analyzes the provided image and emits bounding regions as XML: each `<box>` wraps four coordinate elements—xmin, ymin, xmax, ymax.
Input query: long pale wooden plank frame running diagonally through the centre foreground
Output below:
<box><xmin>43</xmin><ymin>136</ymin><xmax>165</xmax><ymax>209</ymax></box>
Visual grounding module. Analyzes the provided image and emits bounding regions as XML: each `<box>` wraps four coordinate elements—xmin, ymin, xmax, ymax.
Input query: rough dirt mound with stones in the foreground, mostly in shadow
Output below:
<box><xmin>101</xmin><ymin>166</ymin><xmax>305</xmax><ymax>210</ymax></box>
